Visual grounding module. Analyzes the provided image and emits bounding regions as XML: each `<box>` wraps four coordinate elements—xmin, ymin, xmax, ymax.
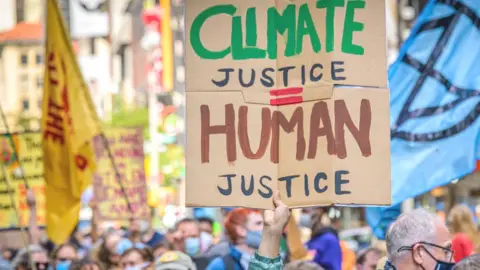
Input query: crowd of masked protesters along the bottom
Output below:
<box><xmin>0</xmin><ymin>190</ymin><xmax>480</xmax><ymax>270</ymax></box>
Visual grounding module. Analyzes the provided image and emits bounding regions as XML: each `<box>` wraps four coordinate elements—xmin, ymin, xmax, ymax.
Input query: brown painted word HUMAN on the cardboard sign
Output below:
<box><xmin>200</xmin><ymin>99</ymin><xmax>372</xmax><ymax>164</ymax></box>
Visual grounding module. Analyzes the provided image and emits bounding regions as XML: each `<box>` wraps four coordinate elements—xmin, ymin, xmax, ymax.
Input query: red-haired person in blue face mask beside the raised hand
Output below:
<box><xmin>207</xmin><ymin>208</ymin><xmax>263</xmax><ymax>270</ymax></box>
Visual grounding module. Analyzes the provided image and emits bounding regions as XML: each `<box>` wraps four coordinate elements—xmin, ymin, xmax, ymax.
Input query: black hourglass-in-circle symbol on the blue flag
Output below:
<box><xmin>391</xmin><ymin>0</ymin><xmax>480</xmax><ymax>142</ymax></box>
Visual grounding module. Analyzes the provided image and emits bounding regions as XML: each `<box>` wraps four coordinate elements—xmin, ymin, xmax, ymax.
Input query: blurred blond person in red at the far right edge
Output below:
<box><xmin>447</xmin><ymin>205</ymin><xmax>480</xmax><ymax>262</ymax></box>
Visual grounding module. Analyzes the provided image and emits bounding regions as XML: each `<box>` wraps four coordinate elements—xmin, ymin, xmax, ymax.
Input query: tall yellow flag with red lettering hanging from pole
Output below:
<box><xmin>42</xmin><ymin>0</ymin><xmax>101</xmax><ymax>244</ymax></box>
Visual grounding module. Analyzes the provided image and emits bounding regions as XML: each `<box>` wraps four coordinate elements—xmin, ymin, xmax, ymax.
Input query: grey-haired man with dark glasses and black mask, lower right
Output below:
<box><xmin>385</xmin><ymin>209</ymin><xmax>455</xmax><ymax>270</ymax></box>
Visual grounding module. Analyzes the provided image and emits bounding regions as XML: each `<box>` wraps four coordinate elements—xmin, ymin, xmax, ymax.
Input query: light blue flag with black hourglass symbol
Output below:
<box><xmin>369</xmin><ymin>0</ymin><xmax>480</xmax><ymax>236</ymax></box>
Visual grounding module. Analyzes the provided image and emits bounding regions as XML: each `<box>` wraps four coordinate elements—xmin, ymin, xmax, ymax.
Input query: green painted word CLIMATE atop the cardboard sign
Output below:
<box><xmin>190</xmin><ymin>0</ymin><xmax>366</xmax><ymax>60</ymax></box>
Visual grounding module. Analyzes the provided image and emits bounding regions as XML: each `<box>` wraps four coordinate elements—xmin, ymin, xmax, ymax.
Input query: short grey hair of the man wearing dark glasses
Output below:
<box><xmin>386</xmin><ymin>208</ymin><xmax>440</xmax><ymax>262</ymax></box>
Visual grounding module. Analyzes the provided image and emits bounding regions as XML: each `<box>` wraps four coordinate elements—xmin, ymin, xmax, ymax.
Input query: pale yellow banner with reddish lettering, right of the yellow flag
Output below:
<box><xmin>93</xmin><ymin>128</ymin><xmax>149</xmax><ymax>221</ymax></box>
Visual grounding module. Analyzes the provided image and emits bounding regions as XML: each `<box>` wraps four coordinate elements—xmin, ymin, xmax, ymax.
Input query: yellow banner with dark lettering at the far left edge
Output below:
<box><xmin>0</xmin><ymin>133</ymin><xmax>45</xmax><ymax>229</ymax></box>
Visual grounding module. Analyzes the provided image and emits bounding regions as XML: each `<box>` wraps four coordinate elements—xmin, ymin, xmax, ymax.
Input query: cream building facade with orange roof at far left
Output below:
<box><xmin>0</xmin><ymin>22</ymin><xmax>43</xmax><ymax>132</ymax></box>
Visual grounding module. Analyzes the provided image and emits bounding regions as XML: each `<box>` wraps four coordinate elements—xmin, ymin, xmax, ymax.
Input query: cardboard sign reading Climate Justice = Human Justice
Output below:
<box><xmin>185</xmin><ymin>0</ymin><xmax>390</xmax><ymax>208</ymax></box>
